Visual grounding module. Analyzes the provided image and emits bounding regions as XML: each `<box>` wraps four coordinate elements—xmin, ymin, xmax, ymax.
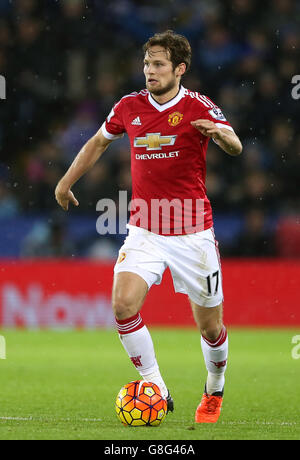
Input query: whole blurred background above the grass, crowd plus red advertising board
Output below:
<box><xmin>0</xmin><ymin>0</ymin><xmax>300</xmax><ymax>327</ymax></box>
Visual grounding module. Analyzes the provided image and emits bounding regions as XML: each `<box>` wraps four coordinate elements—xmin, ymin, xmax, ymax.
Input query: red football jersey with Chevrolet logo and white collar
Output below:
<box><xmin>102</xmin><ymin>86</ymin><xmax>233</xmax><ymax>235</ymax></box>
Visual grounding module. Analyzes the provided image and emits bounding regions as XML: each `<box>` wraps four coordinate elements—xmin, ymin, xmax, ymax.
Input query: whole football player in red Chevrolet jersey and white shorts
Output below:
<box><xmin>55</xmin><ymin>30</ymin><xmax>242</xmax><ymax>423</ymax></box>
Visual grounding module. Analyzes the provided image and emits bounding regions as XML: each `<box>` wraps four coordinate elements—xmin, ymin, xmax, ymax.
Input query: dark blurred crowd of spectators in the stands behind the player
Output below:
<box><xmin>0</xmin><ymin>0</ymin><xmax>300</xmax><ymax>256</ymax></box>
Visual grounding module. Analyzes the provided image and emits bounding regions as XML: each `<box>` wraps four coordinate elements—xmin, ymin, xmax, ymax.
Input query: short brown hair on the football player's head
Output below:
<box><xmin>143</xmin><ymin>30</ymin><xmax>192</xmax><ymax>71</ymax></box>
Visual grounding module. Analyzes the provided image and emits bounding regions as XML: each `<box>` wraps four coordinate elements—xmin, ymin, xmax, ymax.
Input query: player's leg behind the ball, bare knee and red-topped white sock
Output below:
<box><xmin>112</xmin><ymin>271</ymin><xmax>172</xmax><ymax>404</ymax></box>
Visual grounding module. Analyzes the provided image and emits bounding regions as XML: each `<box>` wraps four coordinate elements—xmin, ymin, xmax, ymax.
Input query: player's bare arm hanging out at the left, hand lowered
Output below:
<box><xmin>55</xmin><ymin>128</ymin><xmax>112</xmax><ymax>211</ymax></box>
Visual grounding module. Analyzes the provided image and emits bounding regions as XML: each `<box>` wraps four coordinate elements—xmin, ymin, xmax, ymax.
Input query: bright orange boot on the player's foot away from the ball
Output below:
<box><xmin>195</xmin><ymin>388</ymin><xmax>223</xmax><ymax>423</ymax></box>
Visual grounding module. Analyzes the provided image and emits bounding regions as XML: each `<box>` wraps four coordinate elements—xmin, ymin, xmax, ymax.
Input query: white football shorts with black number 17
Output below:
<box><xmin>114</xmin><ymin>225</ymin><xmax>223</xmax><ymax>307</ymax></box>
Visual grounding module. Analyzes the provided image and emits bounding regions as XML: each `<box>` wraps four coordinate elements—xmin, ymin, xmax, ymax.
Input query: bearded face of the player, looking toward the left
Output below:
<box><xmin>144</xmin><ymin>46</ymin><xmax>179</xmax><ymax>96</ymax></box>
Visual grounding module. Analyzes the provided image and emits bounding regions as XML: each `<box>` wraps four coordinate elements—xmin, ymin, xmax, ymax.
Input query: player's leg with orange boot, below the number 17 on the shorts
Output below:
<box><xmin>190</xmin><ymin>300</ymin><xmax>228</xmax><ymax>423</ymax></box>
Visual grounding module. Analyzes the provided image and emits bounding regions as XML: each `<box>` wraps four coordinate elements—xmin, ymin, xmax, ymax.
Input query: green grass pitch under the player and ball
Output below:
<box><xmin>0</xmin><ymin>329</ymin><xmax>300</xmax><ymax>440</ymax></box>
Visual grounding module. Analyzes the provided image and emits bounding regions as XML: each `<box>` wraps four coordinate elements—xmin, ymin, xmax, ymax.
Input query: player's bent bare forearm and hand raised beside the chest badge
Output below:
<box><xmin>191</xmin><ymin>119</ymin><xmax>243</xmax><ymax>156</ymax></box>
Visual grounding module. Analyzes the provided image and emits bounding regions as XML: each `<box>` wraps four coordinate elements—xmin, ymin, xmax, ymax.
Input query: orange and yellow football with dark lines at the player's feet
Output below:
<box><xmin>116</xmin><ymin>380</ymin><xmax>167</xmax><ymax>426</ymax></box>
